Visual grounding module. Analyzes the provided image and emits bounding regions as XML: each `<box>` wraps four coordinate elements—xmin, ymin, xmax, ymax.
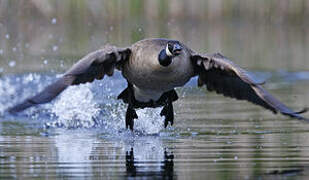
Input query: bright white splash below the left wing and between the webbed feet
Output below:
<box><xmin>47</xmin><ymin>84</ymin><xmax>163</xmax><ymax>134</ymax></box>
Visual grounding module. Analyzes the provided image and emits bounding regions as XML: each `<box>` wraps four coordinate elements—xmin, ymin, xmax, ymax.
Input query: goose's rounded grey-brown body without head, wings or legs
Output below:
<box><xmin>122</xmin><ymin>39</ymin><xmax>194</xmax><ymax>102</ymax></box>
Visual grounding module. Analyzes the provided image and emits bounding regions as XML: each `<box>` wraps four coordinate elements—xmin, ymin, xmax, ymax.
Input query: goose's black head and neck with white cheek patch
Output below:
<box><xmin>159</xmin><ymin>41</ymin><xmax>183</xmax><ymax>67</ymax></box>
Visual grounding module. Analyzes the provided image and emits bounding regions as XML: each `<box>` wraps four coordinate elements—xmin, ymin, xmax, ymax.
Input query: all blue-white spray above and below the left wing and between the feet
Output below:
<box><xmin>0</xmin><ymin>73</ymin><xmax>176</xmax><ymax>134</ymax></box>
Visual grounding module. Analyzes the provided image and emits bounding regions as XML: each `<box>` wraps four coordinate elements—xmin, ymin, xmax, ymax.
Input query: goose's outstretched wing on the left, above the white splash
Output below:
<box><xmin>9</xmin><ymin>46</ymin><xmax>131</xmax><ymax>113</ymax></box>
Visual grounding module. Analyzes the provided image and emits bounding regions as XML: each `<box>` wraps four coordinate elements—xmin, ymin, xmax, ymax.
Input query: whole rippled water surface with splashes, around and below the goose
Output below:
<box><xmin>0</xmin><ymin>72</ymin><xmax>309</xmax><ymax>179</ymax></box>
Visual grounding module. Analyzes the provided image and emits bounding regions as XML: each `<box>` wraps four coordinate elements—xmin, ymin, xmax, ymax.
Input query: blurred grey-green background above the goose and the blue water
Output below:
<box><xmin>0</xmin><ymin>0</ymin><xmax>309</xmax><ymax>74</ymax></box>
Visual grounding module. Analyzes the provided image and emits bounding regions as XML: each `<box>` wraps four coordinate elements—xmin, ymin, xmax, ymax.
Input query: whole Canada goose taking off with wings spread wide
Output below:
<box><xmin>9</xmin><ymin>39</ymin><xmax>308</xmax><ymax>130</ymax></box>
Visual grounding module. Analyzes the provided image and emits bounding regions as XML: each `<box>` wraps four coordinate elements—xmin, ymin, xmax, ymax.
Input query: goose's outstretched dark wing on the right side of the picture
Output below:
<box><xmin>192</xmin><ymin>53</ymin><xmax>309</xmax><ymax>121</ymax></box>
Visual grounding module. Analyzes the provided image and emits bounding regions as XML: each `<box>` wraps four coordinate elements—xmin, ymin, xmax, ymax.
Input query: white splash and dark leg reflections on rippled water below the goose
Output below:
<box><xmin>52</xmin><ymin>131</ymin><xmax>173</xmax><ymax>179</ymax></box>
